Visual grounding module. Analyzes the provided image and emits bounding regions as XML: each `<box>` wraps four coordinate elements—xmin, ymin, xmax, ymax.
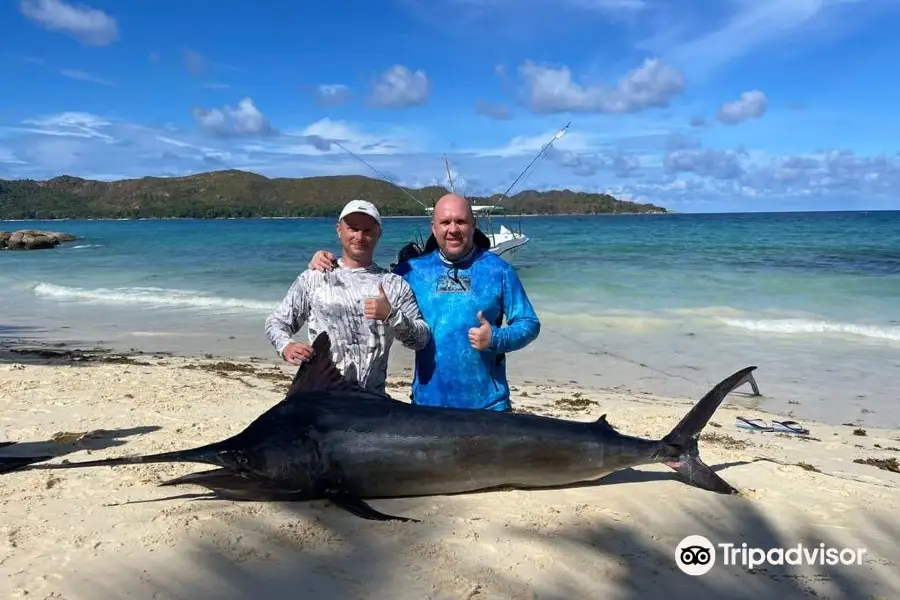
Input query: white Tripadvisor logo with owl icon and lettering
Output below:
<box><xmin>675</xmin><ymin>535</ymin><xmax>866</xmax><ymax>576</ymax></box>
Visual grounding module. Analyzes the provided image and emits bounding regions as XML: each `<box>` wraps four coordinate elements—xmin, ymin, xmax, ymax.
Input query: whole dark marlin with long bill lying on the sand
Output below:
<box><xmin>8</xmin><ymin>333</ymin><xmax>756</xmax><ymax>521</ymax></box>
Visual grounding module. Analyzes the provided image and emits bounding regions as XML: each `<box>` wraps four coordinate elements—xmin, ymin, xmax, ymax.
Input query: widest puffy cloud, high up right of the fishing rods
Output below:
<box><xmin>519</xmin><ymin>59</ymin><xmax>685</xmax><ymax>114</ymax></box>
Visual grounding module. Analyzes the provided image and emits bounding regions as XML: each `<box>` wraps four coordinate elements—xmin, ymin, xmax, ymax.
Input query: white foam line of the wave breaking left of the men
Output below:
<box><xmin>34</xmin><ymin>283</ymin><xmax>274</xmax><ymax>312</ymax></box>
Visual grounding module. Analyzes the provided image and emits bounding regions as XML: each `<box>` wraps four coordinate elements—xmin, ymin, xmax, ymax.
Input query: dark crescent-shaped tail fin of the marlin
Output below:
<box><xmin>663</xmin><ymin>367</ymin><xmax>756</xmax><ymax>494</ymax></box>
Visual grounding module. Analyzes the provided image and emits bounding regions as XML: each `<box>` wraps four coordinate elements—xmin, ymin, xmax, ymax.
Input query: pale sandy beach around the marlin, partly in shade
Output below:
<box><xmin>0</xmin><ymin>344</ymin><xmax>900</xmax><ymax>600</ymax></box>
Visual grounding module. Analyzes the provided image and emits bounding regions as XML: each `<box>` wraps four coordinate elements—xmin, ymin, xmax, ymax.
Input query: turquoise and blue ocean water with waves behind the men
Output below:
<box><xmin>0</xmin><ymin>212</ymin><xmax>900</xmax><ymax>427</ymax></box>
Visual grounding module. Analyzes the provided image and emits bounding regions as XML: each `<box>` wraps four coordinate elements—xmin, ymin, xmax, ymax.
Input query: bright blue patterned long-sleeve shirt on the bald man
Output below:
<box><xmin>395</xmin><ymin>248</ymin><xmax>541</xmax><ymax>410</ymax></box>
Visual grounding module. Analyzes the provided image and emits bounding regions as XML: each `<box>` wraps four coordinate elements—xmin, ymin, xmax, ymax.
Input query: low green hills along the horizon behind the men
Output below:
<box><xmin>0</xmin><ymin>170</ymin><xmax>667</xmax><ymax>219</ymax></box>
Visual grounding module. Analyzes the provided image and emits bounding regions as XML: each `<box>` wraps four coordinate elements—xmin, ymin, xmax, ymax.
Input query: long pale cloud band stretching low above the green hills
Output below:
<box><xmin>0</xmin><ymin>111</ymin><xmax>900</xmax><ymax>210</ymax></box>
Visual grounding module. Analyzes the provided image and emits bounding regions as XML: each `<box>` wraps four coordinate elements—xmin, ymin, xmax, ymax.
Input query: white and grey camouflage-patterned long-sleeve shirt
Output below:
<box><xmin>265</xmin><ymin>261</ymin><xmax>431</xmax><ymax>394</ymax></box>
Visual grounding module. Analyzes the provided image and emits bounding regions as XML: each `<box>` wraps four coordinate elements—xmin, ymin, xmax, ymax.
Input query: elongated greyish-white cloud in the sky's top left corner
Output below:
<box><xmin>19</xmin><ymin>0</ymin><xmax>119</xmax><ymax>46</ymax></box>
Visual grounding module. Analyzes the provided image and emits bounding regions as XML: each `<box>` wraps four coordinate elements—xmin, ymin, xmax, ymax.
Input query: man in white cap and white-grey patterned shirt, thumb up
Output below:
<box><xmin>265</xmin><ymin>200</ymin><xmax>431</xmax><ymax>394</ymax></box>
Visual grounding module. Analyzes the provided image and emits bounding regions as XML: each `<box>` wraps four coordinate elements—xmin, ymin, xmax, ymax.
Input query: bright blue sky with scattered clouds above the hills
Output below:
<box><xmin>0</xmin><ymin>0</ymin><xmax>900</xmax><ymax>212</ymax></box>
